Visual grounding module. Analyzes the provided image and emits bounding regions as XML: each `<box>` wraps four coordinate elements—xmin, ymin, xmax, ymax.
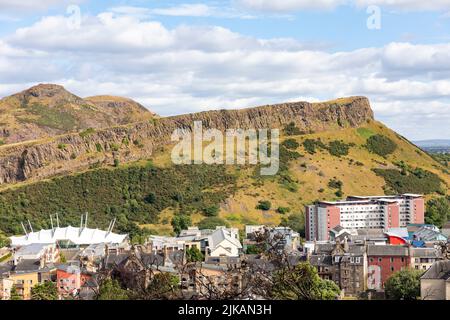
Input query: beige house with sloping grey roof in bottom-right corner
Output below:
<box><xmin>420</xmin><ymin>260</ymin><xmax>450</xmax><ymax>300</ymax></box>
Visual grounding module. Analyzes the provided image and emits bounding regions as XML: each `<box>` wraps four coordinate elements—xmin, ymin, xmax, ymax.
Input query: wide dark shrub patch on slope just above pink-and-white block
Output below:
<box><xmin>373</xmin><ymin>168</ymin><xmax>442</xmax><ymax>194</ymax></box>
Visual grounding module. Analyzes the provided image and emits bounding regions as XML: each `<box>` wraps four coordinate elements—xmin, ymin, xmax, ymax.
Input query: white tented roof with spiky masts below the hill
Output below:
<box><xmin>10</xmin><ymin>226</ymin><xmax>127</xmax><ymax>246</ymax></box>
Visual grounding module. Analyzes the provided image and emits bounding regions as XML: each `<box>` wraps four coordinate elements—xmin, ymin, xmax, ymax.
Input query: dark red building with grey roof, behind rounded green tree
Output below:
<box><xmin>367</xmin><ymin>245</ymin><xmax>411</xmax><ymax>291</ymax></box>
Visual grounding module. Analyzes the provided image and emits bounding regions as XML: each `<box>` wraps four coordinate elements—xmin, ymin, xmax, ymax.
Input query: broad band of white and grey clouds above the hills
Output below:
<box><xmin>0</xmin><ymin>12</ymin><xmax>450</xmax><ymax>139</ymax></box>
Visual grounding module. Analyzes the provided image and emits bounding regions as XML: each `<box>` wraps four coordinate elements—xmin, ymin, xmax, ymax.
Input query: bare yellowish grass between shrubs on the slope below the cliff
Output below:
<box><xmin>0</xmin><ymin>122</ymin><xmax>450</xmax><ymax>234</ymax></box>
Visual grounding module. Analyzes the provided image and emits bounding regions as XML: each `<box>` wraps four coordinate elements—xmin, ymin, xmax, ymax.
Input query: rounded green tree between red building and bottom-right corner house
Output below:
<box><xmin>385</xmin><ymin>269</ymin><xmax>422</xmax><ymax>300</ymax></box>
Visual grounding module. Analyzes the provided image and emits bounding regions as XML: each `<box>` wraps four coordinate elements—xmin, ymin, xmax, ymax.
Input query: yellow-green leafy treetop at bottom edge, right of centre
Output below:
<box><xmin>272</xmin><ymin>262</ymin><xmax>340</xmax><ymax>300</ymax></box>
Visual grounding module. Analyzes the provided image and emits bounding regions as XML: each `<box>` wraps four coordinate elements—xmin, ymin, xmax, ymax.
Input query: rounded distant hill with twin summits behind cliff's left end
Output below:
<box><xmin>0</xmin><ymin>84</ymin><xmax>154</xmax><ymax>145</ymax></box>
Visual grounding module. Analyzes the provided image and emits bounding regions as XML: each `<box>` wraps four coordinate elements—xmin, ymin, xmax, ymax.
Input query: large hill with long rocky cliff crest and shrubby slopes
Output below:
<box><xmin>0</xmin><ymin>92</ymin><xmax>450</xmax><ymax>240</ymax></box>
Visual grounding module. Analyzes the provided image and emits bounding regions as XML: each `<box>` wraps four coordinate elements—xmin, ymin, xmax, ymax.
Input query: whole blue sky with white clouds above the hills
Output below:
<box><xmin>0</xmin><ymin>0</ymin><xmax>450</xmax><ymax>140</ymax></box>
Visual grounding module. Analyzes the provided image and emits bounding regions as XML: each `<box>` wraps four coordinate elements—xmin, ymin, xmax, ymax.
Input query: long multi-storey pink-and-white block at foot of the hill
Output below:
<box><xmin>305</xmin><ymin>194</ymin><xmax>424</xmax><ymax>241</ymax></box>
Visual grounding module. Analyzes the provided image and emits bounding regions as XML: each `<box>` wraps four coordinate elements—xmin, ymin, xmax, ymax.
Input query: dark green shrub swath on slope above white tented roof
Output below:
<box><xmin>0</xmin><ymin>165</ymin><xmax>236</xmax><ymax>235</ymax></box>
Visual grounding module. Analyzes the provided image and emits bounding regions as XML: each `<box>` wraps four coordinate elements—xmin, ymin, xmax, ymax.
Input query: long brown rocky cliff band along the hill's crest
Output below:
<box><xmin>0</xmin><ymin>97</ymin><xmax>373</xmax><ymax>185</ymax></box>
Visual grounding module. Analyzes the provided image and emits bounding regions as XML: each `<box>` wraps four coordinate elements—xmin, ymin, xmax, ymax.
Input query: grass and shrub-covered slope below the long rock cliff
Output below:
<box><xmin>0</xmin><ymin>117</ymin><xmax>444</xmax><ymax>238</ymax></box>
